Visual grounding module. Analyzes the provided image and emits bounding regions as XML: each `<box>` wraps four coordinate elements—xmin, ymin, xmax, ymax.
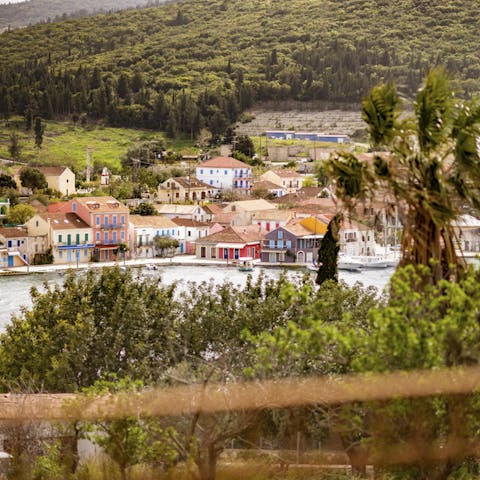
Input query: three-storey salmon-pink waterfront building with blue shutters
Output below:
<box><xmin>56</xmin><ymin>197</ymin><xmax>130</xmax><ymax>262</ymax></box>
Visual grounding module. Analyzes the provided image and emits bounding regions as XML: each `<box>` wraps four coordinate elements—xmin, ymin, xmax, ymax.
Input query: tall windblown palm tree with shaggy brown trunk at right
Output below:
<box><xmin>328</xmin><ymin>68</ymin><xmax>480</xmax><ymax>283</ymax></box>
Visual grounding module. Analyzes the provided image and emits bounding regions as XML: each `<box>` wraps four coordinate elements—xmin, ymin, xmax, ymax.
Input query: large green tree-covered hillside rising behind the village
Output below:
<box><xmin>0</xmin><ymin>0</ymin><xmax>480</xmax><ymax>136</ymax></box>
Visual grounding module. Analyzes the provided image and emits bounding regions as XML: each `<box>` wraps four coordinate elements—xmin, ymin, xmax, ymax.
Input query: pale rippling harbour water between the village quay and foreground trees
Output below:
<box><xmin>0</xmin><ymin>265</ymin><xmax>393</xmax><ymax>331</ymax></box>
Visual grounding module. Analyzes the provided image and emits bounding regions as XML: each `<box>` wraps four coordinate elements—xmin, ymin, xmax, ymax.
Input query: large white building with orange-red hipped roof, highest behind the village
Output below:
<box><xmin>196</xmin><ymin>157</ymin><xmax>253</xmax><ymax>195</ymax></box>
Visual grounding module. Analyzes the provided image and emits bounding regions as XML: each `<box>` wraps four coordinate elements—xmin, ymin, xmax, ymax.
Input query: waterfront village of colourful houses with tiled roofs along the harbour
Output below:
<box><xmin>0</xmin><ymin>139</ymin><xmax>480</xmax><ymax>273</ymax></box>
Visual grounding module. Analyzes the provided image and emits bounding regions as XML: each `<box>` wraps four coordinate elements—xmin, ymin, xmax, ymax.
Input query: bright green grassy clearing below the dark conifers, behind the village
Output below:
<box><xmin>0</xmin><ymin>117</ymin><xmax>196</xmax><ymax>173</ymax></box>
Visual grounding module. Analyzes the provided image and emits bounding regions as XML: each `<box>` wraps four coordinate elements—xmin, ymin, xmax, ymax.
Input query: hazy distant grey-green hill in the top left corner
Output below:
<box><xmin>0</xmin><ymin>0</ymin><xmax>165</xmax><ymax>31</ymax></box>
